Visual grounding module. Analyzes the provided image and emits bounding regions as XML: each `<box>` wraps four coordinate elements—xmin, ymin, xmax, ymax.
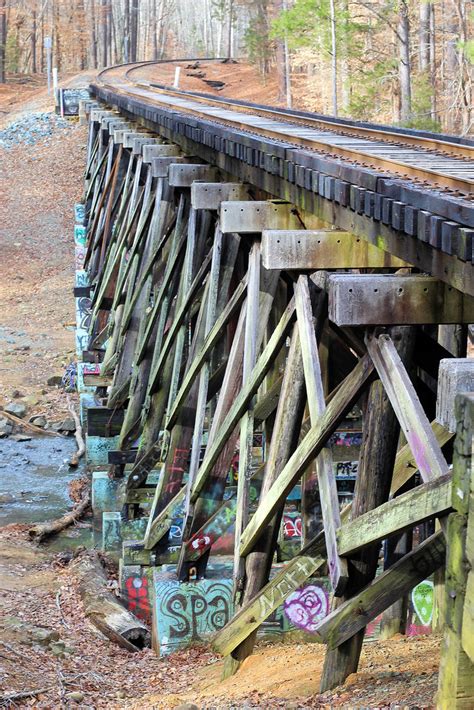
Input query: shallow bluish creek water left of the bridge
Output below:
<box><xmin>0</xmin><ymin>436</ymin><xmax>82</xmax><ymax>526</ymax></box>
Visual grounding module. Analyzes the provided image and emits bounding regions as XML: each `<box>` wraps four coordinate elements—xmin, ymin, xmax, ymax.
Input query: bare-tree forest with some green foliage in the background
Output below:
<box><xmin>0</xmin><ymin>0</ymin><xmax>474</xmax><ymax>134</ymax></box>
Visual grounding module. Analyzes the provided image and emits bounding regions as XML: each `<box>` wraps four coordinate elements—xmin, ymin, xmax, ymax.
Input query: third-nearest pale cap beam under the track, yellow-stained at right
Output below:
<box><xmin>220</xmin><ymin>200</ymin><xmax>303</xmax><ymax>234</ymax></box>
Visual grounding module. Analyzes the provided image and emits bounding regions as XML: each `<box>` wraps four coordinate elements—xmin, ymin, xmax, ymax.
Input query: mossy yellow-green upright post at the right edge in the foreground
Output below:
<box><xmin>436</xmin><ymin>394</ymin><xmax>474</xmax><ymax>710</ymax></box>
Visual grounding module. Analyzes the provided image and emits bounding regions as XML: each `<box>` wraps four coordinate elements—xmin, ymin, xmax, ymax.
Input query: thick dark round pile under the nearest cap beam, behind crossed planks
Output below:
<box><xmin>320</xmin><ymin>328</ymin><xmax>413</xmax><ymax>693</ymax></box>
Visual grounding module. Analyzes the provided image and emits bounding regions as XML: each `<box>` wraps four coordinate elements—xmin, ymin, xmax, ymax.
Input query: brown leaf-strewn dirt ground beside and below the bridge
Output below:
<box><xmin>0</xmin><ymin>73</ymin><xmax>439</xmax><ymax>710</ymax></box>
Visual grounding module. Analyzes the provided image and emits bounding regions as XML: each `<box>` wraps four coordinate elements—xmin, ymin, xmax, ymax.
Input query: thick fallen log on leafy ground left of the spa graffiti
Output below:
<box><xmin>70</xmin><ymin>551</ymin><xmax>151</xmax><ymax>651</ymax></box>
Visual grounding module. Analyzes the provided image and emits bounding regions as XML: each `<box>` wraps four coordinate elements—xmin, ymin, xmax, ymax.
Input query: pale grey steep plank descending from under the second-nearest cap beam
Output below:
<box><xmin>295</xmin><ymin>276</ymin><xmax>349</xmax><ymax>596</ymax></box>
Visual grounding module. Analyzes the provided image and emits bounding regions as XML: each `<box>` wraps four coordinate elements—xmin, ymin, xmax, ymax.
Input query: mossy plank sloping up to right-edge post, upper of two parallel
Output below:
<box><xmin>336</xmin><ymin>474</ymin><xmax>452</xmax><ymax>557</ymax></box>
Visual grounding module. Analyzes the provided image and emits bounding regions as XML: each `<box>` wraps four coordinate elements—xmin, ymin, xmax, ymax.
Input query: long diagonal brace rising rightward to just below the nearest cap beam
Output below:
<box><xmin>241</xmin><ymin>355</ymin><xmax>374</xmax><ymax>555</ymax></box>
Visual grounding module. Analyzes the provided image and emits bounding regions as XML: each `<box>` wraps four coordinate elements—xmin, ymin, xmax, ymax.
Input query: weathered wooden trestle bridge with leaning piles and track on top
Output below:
<box><xmin>76</xmin><ymin>59</ymin><xmax>474</xmax><ymax>708</ymax></box>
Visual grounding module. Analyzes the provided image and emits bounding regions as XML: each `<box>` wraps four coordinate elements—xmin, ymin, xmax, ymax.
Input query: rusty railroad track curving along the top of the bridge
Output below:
<box><xmin>98</xmin><ymin>59</ymin><xmax>474</xmax><ymax>199</ymax></box>
